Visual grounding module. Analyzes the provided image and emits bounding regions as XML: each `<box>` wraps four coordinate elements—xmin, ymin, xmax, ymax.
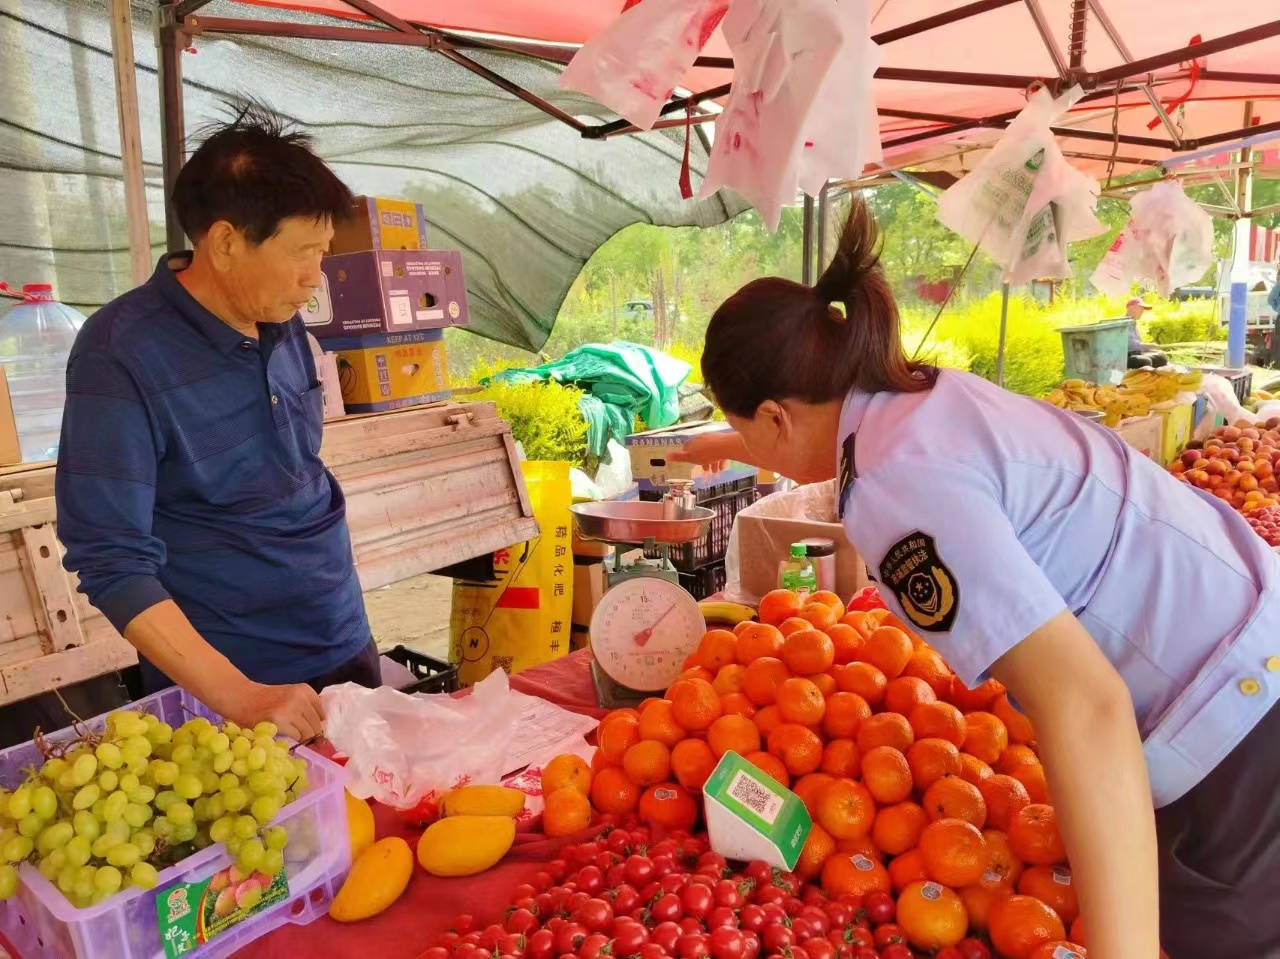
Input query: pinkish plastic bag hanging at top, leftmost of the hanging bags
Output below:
<box><xmin>559</xmin><ymin>0</ymin><xmax>728</xmax><ymax>129</ymax></box>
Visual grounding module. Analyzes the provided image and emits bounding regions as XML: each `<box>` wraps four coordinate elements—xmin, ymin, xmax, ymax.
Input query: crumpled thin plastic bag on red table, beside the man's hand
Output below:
<box><xmin>320</xmin><ymin>671</ymin><xmax>524</xmax><ymax>809</ymax></box>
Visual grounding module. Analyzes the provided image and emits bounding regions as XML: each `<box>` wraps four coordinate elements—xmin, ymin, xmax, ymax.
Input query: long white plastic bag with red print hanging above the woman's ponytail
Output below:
<box><xmin>696</xmin><ymin>0</ymin><xmax>845</xmax><ymax>229</ymax></box>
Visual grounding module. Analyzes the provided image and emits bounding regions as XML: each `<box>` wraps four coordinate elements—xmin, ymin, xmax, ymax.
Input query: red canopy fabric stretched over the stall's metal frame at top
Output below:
<box><xmin>238</xmin><ymin>0</ymin><xmax>1280</xmax><ymax>173</ymax></box>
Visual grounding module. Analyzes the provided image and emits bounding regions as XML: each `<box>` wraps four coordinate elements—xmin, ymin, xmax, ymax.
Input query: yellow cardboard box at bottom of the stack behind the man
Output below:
<box><xmin>325</xmin><ymin>329</ymin><xmax>449</xmax><ymax>414</ymax></box>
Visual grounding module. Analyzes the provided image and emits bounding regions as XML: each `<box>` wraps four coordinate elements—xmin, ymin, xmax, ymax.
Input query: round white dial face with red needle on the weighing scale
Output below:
<box><xmin>590</xmin><ymin>576</ymin><xmax>707</xmax><ymax>693</ymax></box>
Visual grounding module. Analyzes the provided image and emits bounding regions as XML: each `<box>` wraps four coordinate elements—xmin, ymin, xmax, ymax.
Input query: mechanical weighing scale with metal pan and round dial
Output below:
<box><xmin>570</xmin><ymin>480</ymin><xmax>716</xmax><ymax>709</ymax></box>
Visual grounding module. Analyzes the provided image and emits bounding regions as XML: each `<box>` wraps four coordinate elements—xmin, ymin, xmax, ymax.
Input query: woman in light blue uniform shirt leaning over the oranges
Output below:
<box><xmin>685</xmin><ymin>198</ymin><xmax>1280</xmax><ymax>959</ymax></box>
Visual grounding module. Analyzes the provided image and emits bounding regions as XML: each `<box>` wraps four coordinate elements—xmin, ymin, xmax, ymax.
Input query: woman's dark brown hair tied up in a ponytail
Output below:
<box><xmin>703</xmin><ymin>198</ymin><xmax>937</xmax><ymax>417</ymax></box>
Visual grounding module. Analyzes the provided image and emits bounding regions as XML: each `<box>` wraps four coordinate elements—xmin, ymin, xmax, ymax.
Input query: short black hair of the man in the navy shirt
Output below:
<box><xmin>173</xmin><ymin>102</ymin><xmax>355</xmax><ymax>243</ymax></box>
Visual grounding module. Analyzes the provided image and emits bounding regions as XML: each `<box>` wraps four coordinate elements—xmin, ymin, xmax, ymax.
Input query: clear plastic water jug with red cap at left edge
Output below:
<box><xmin>0</xmin><ymin>283</ymin><xmax>84</xmax><ymax>462</ymax></box>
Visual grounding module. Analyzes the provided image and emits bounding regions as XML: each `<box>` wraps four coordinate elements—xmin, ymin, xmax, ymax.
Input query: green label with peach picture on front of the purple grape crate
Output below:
<box><xmin>156</xmin><ymin>866</ymin><xmax>289</xmax><ymax>959</ymax></box>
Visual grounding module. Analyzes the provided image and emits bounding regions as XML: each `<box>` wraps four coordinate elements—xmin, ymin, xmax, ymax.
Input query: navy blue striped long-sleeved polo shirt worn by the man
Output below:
<box><xmin>56</xmin><ymin>254</ymin><xmax>370</xmax><ymax>689</ymax></box>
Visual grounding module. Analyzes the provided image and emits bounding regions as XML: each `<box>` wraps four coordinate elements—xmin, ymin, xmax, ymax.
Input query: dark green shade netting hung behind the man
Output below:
<box><xmin>0</xmin><ymin>0</ymin><xmax>746</xmax><ymax>351</ymax></box>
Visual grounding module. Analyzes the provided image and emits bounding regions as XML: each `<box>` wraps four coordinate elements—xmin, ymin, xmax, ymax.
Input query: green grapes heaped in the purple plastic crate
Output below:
<box><xmin>0</xmin><ymin>709</ymin><xmax>307</xmax><ymax>908</ymax></box>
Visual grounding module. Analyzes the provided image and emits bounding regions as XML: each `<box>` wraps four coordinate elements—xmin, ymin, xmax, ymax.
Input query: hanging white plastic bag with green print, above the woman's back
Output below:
<box><xmin>938</xmin><ymin>87</ymin><xmax>1103</xmax><ymax>284</ymax></box>
